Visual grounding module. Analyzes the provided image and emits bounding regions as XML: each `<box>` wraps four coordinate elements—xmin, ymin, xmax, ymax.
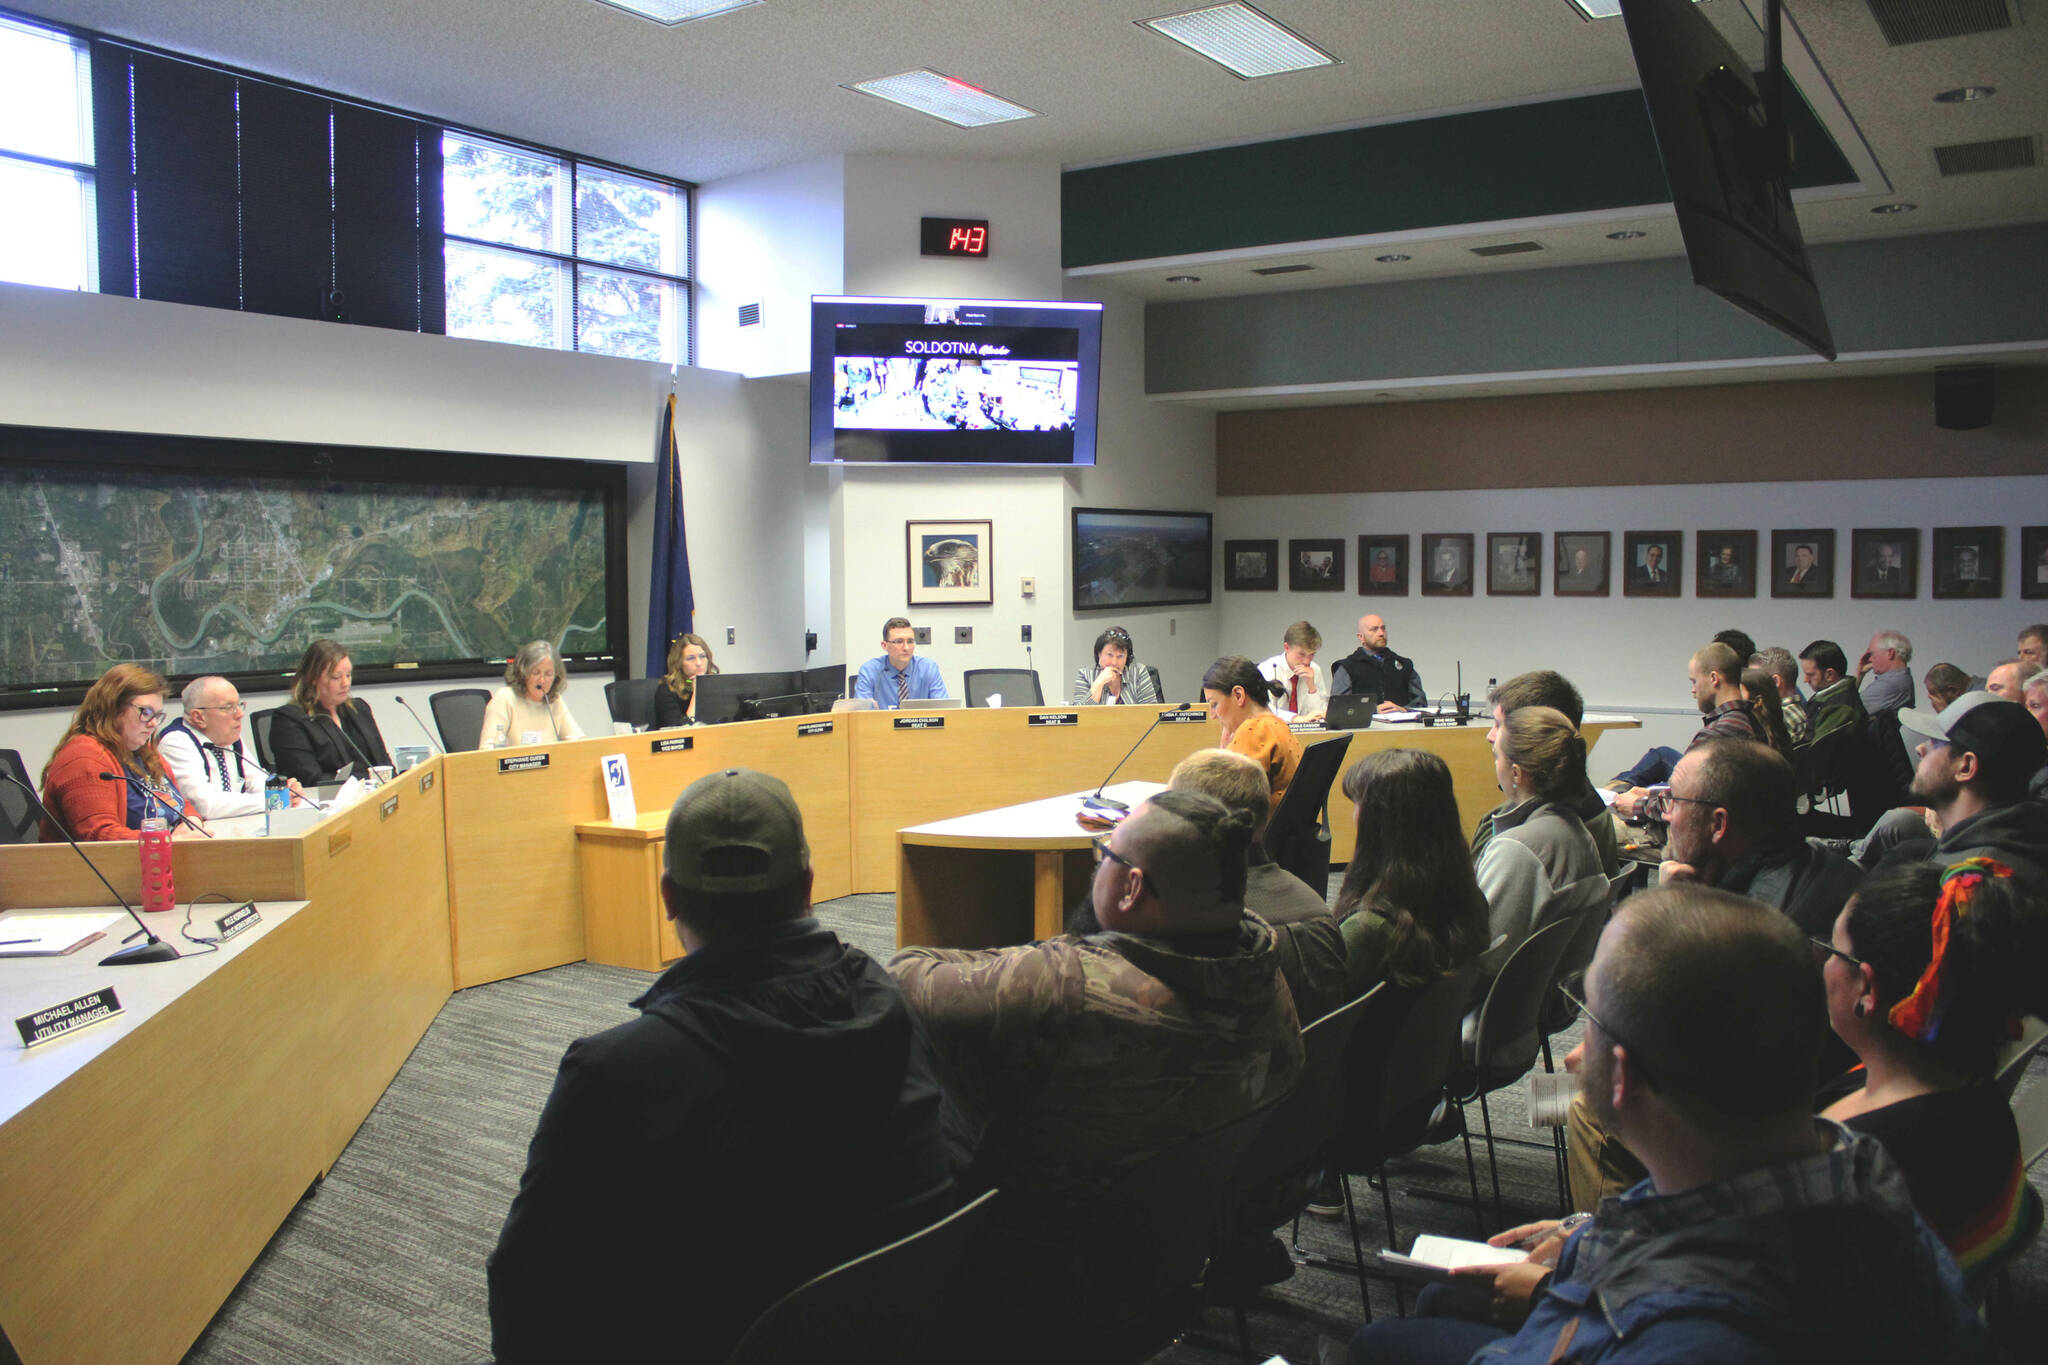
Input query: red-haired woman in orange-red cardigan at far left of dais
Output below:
<box><xmin>43</xmin><ymin>663</ymin><xmax>197</xmax><ymax>843</ymax></box>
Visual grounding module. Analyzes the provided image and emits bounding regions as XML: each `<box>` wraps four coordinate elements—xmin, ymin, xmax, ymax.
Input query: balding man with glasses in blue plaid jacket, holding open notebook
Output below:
<box><xmin>1350</xmin><ymin>886</ymin><xmax>1999</xmax><ymax>1365</ymax></box>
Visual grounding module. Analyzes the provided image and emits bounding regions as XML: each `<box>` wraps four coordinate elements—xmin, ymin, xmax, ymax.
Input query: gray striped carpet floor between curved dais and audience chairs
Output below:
<box><xmin>172</xmin><ymin>896</ymin><xmax>2048</xmax><ymax>1365</ymax></box>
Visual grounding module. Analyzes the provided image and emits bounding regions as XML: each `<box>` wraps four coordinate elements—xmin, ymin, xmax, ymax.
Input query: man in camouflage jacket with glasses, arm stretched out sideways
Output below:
<box><xmin>888</xmin><ymin>792</ymin><xmax>1303</xmax><ymax>1236</ymax></box>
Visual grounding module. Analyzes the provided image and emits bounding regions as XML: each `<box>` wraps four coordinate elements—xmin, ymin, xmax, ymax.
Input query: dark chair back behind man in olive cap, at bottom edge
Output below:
<box><xmin>725</xmin><ymin>1189</ymin><xmax>995</xmax><ymax>1365</ymax></box>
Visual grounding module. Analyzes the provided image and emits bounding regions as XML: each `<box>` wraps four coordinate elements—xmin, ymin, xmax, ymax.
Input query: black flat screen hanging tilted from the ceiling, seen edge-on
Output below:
<box><xmin>1622</xmin><ymin>0</ymin><xmax>1835</xmax><ymax>360</ymax></box>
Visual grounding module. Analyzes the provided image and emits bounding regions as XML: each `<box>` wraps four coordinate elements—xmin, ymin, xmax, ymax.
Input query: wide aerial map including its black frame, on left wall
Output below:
<box><xmin>0</xmin><ymin>428</ymin><xmax>627</xmax><ymax>708</ymax></box>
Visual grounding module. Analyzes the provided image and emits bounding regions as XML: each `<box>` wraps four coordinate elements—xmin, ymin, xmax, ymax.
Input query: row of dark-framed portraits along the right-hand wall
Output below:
<box><xmin>1223</xmin><ymin>526</ymin><xmax>2048</xmax><ymax>598</ymax></box>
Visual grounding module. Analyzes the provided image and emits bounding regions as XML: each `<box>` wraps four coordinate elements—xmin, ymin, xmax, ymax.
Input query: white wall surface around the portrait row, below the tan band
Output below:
<box><xmin>1217</xmin><ymin>477</ymin><xmax>2048</xmax><ymax>776</ymax></box>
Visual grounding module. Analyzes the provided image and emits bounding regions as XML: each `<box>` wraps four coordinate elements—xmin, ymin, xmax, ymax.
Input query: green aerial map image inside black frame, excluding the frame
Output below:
<box><xmin>0</xmin><ymin>467</ymin><xmax>610</xmax><ymax>690</ymax></box>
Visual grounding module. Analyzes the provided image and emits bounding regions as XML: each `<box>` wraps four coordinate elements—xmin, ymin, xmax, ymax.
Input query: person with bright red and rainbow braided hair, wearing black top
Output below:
<box><xmin>1815</xmin><ymin>857</ymin><xmax>2048</xmax><ymax>1275</ymax></box>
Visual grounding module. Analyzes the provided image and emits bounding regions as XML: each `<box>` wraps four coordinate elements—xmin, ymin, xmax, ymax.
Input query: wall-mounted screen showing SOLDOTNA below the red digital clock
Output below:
<box><xmin>811</xmin><ymin>297</ymin><xmax>1102</xmax><ymax>465</ymax></box>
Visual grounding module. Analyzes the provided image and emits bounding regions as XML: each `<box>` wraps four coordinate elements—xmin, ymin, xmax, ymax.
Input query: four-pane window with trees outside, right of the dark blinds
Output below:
<box><xmin>440</xmin><ymin>133</ymin><xmax>690</xmax><ymax>362</ymax></box>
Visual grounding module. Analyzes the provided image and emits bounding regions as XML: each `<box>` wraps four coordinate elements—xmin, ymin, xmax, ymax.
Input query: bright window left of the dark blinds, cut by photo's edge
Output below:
<box><xmin>0</xmin><ymin>18</ymin><xmax>98</xmax><ymax>291</ymax></box>
